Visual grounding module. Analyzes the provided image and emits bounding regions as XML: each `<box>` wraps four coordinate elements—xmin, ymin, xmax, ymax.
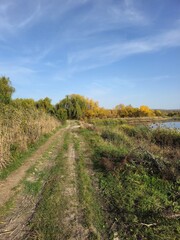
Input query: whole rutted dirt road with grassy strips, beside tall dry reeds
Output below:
<box><xmin>0</xmin><ymin>121</ymin><xmax>101</xmax><ymax>240</ymax></box>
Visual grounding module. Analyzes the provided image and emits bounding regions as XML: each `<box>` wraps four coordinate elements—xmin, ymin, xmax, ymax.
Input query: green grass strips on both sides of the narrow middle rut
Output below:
<box><xmin>26</xmin><ymin>125</ymin><xmax>106</xmax><ymax>240</ymax></box>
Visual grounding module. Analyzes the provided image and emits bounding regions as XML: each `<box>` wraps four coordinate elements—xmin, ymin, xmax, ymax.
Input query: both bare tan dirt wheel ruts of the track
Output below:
<box><xmin>0</xmin><ymin>122</ymin><xmax>89</xmax><ymax>240</ymax></box>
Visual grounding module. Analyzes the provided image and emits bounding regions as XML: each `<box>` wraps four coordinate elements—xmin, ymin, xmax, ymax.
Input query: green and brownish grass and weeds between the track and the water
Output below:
<box><xmin>82</xmin><ymin>122</ymin><xmax>180</xmax><ymax>240</ymax></box>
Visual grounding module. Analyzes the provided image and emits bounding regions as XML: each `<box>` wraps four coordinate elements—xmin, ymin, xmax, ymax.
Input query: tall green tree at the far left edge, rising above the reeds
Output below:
<box><xmin>0</xmin><ymin>76</ymin><xmax>15</xmax><ymax>104</ymax></box>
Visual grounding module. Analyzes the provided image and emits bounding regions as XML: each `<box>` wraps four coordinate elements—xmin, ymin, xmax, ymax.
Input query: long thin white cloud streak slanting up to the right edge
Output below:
<box><xmin>68</xmin><ymin>27</ymin><xmax>180</xmax><ymax>71</ymax></box>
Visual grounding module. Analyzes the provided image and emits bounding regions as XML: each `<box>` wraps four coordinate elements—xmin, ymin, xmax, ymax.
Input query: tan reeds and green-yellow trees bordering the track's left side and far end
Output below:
<box><xmin>0</xmin><ymin>76</ymin><xmax>178</xmax><ymax>172</ymax></box>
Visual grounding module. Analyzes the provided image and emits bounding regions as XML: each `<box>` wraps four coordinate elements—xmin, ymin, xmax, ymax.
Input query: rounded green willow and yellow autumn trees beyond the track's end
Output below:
<box><xmin>56</xmin><ymin>94</ymin><xmax>165</xmax><ymax>119</ymax></box>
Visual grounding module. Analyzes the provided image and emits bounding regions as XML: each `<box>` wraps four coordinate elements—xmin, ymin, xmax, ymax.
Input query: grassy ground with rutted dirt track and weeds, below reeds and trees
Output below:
<box><xmin>0</xmin><ymin>119</ymin><xmax>180</xmax><ymax>240</ymax></box>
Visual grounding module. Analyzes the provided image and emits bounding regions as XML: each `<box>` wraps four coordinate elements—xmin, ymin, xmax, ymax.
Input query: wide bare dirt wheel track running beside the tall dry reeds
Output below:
<box><xmin>0</xmin><ymin>125</ymin><xmax>70</xmax><ymax>240</ymax></box>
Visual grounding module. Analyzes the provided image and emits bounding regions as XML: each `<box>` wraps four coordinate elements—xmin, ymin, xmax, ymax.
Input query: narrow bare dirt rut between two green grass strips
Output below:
<box><xmin>54</xmin><ymin>144</ymin><xmax>89</xmax><ymax>240</ymax></box>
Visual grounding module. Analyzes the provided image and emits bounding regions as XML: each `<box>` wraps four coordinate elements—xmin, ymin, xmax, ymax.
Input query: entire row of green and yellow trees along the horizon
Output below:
<box><xmin>0</xmin><ymin>76</ymin><xmax>162</xmax><ymax>121</ymax></box>
